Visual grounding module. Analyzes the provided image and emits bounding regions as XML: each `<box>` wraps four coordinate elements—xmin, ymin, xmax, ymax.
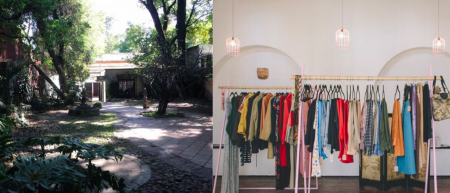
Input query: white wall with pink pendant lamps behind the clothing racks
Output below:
<box><xmin>213</xmin><ymin>0</ymin><xmax>450</xmax><ymax>176</ymax></box>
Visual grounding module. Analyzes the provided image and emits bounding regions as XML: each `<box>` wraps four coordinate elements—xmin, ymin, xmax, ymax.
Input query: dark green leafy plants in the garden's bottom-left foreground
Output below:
<box><xmin>4</xmin><ymin>137</ymin><xmax>129</xmax><ymax>192</ymax></box>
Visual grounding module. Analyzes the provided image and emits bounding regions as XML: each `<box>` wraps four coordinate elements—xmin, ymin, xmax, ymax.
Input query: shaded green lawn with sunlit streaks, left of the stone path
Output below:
<box><xmin>12</xmin><ymin>110</ymin><xmax>126</xmax><ymax>158</ymax></box>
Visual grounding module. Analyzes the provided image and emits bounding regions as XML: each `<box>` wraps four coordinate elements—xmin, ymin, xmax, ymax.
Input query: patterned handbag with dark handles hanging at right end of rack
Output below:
<box><xmin>432</xmin><ymin>76</ymin><xmax>450</xmax><ymax>121</ymax></box>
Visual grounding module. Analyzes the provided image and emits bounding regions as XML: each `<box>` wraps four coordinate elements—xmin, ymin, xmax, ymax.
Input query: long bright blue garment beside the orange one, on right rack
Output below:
<box><xmin>397</xmin><ymin>97</ymin><xmax>416</xmax><ymax>174</ymax></box>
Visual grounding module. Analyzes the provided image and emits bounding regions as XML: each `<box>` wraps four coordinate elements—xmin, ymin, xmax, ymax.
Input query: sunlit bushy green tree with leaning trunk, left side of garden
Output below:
<box><xmin>32</xmin><ymin>0</ymin><xmax>103</xmax><ymax>98</ymax></box>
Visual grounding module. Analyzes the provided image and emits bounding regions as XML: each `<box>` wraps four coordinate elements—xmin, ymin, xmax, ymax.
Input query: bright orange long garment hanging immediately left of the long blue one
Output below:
<box><xmin>392</xmin><ymin>99</ymin><xmax>405</xmax><ymax>156</ymax></box>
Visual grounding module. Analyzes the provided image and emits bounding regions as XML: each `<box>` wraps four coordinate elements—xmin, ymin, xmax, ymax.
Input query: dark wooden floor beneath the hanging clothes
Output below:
<box><xmin>216</xmin><ymin>176</ymin><xmax>450</xmax><ymax>193</ymax></box>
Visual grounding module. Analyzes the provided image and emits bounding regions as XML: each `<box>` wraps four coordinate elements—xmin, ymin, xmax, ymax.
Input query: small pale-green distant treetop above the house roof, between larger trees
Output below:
<box><xmin>118</xmin><ymin>22</ymin><xmax>146</xmax><ymax>53</ymax></box>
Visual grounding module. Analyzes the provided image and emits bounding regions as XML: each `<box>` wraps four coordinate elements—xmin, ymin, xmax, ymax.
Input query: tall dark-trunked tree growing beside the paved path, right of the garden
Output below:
<box><xmin>135</xmin><ymin>0</ymin><xmax>212</xmax><ymax>114</ymax></box>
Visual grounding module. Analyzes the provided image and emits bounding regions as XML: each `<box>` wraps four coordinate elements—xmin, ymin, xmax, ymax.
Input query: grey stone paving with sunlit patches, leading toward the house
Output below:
<box><xmin>102</xmin><ymin>103</ymin><xmax>212</xmax><ymax>179</ymax></box>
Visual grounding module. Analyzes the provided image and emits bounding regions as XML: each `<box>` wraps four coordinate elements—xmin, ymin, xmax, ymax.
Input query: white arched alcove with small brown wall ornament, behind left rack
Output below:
<box><xmin>213</xmin><ymin>46</ymin><xmax>301</xmax><ymax>175</ymax></box>
